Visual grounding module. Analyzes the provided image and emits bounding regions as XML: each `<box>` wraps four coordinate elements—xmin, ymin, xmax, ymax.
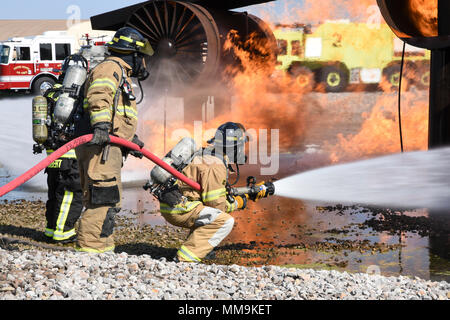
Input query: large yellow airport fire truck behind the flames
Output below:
<box><xmin>274</xmin><ymin>21</ymin><xmax>430</xmax><ymax>92</ymax></box>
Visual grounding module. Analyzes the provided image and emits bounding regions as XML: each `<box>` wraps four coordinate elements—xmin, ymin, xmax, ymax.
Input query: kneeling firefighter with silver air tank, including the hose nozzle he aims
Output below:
<box><xmin>145</xmin><ymin>122</ymin><xmax>273</xmax><ymax>262</ymax></box>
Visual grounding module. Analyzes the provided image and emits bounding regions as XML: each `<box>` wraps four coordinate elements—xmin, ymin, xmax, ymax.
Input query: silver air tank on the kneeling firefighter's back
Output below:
<box><xmin>150</xmin><ymin>138</ymin><xmax>197</xmax><ymax>184</ymax></box>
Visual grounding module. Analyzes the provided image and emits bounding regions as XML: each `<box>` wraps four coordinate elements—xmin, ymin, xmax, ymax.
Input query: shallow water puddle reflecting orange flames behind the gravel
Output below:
<box><xmin>114</xmin><ymin>188</ymin><xmax>450</xmax><ymax>281</ymax></box>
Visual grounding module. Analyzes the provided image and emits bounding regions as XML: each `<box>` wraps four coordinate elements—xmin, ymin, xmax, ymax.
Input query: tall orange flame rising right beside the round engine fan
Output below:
<box><xmin>220</xmin><ymin>31</ymin><xmax>312</xmax><ymax>151</ymax></box>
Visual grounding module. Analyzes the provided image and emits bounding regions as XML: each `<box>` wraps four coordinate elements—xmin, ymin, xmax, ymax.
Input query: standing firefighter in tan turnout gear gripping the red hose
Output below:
<box><xmin>76</xmin><ymin>27</ymin><xmax>153</xmax><ymax>253</ymax></box>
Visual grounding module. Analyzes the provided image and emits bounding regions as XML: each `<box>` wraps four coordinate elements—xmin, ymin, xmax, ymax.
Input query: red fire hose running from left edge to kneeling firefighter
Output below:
<box><xmin>0</xmin><ymin>134</ymin><xmax>201</xmax><ymax>197</ymax></box>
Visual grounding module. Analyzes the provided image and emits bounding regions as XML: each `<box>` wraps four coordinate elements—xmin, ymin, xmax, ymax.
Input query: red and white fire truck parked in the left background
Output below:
<box><xmin>0</xmin><ymin>31</ymin><xmax>76</xmax><ymax>92</ymax></box>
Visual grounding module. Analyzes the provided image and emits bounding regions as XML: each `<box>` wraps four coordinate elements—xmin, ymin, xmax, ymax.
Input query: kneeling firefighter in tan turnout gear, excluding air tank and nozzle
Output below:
<box><xmin>160</xmin><ymin>122</ymin><xmax>248</xmax><ymax>262</ymax></box>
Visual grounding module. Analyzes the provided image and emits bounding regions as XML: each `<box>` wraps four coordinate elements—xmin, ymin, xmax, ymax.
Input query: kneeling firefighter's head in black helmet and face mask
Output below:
<box><xmin>208</xmin><ymin>122</ymin><xmax>249</xmax><ymax>164</ymax></box>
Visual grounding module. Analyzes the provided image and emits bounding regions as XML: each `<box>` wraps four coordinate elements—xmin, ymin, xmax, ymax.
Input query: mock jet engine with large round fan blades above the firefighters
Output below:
<box><xmin>91</xmin><ymin>0</ymin><xmax>276</xmax><ymax>92</ymax></box>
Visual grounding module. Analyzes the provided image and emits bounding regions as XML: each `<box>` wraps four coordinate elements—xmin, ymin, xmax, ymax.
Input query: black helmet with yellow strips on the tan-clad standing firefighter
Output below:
<box><xmin>106</xmin><ymin>27</ymin><xmax>154</xmax><ymax>56</ymax></box>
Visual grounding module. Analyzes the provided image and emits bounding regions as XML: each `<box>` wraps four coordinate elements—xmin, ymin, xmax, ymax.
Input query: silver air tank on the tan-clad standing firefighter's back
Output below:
<box><xmin>53</xmin><ymin>65</ymin><xmax>87</xmax><ymax>127</ymax></box>
